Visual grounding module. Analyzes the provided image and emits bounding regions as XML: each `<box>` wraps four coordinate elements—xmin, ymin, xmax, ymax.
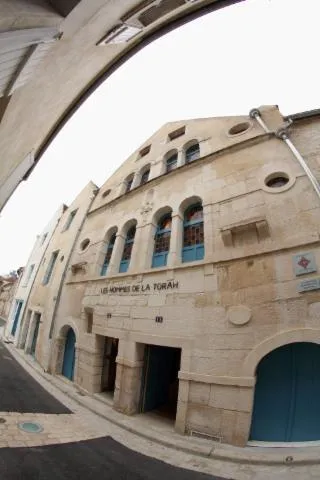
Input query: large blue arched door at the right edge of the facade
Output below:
<box><xmin>250</xmin><ymin>342</ymin><xmax>320</xmax><ymax>442</ymax></box>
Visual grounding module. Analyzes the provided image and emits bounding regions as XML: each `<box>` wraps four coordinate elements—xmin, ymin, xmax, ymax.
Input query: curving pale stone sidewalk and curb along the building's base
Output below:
<box><xmin>2</xmin><ymin>342</ymin><xmax>320</xmax><ymax>466</ymax></box>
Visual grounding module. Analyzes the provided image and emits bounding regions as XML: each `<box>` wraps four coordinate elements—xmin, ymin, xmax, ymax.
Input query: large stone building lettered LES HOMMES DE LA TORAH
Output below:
<box><xmin>13</xmin><ymin>107</ymin><xmax>320</xmax><ymax>446</ymax></box>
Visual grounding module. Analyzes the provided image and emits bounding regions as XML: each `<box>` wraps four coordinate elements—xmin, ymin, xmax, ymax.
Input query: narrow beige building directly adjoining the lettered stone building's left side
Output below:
<box><xmin>17</xmin><ymin>182</ymin><xmax>97</xmax><ymax>370</ymax></box>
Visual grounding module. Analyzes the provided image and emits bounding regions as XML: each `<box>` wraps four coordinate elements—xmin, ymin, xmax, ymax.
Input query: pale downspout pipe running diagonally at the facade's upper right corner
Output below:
<box><xmin>249</xmin><ymin>108</ymin><xmax>320</xmax><ymax>198</ymax></box>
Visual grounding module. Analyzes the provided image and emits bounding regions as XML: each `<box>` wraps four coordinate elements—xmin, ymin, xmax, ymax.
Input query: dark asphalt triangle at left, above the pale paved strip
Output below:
<box><xmin>0</xmin><ymin>343</ymin><xmax>72</xmax><ymax>414</ymax></box>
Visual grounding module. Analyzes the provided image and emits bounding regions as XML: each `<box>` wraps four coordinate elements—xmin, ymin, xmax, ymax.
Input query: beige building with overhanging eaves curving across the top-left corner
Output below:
<box><xmin>0</xmin><ymin>0</ymin><xmax>244</xmax><ymax>211</ymax></box>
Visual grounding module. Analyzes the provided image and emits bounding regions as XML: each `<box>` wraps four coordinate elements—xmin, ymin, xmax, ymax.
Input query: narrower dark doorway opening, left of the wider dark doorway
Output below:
<box><xmin>101</xmin><ymin>337</ymin><xmax>119</xmax><ymax>393</ymax></box>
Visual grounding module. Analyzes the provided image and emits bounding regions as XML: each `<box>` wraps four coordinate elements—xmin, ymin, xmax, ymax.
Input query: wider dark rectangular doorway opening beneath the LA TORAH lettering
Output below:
<box><xmin>140</xmin><ymin>345</ymin><xmax>181</xmax><ymax>419</ymax></box>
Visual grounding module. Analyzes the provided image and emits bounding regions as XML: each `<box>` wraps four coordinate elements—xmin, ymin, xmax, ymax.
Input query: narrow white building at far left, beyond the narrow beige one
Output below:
<box><xmin>5</xmin><ymin>205</ymin><xmax>67</xmax><ymax>345</ymax></box>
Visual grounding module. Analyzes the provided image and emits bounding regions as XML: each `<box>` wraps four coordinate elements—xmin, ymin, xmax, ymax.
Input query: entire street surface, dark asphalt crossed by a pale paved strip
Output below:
<box><xmin>0</xmin><ymin>343</ymin><xmax>230</xmax><ymax>480</ymax></box>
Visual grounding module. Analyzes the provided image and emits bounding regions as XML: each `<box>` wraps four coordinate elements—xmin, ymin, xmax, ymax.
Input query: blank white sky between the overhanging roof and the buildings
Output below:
<box><xmin>0</xmin><ymin>0</ymin><xmax>320</xmax><ymax>274</ymax></box>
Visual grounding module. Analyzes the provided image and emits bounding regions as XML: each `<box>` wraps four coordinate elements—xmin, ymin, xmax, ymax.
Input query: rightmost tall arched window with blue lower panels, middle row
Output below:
<box><xmin>182</xmin><ymin>203</ymin><xmax>204</xmax><ymax>262</ymax></box>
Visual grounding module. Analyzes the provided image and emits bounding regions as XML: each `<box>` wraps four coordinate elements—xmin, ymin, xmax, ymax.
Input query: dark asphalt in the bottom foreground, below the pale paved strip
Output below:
<box><xmin>0</xmin><ymin>437</ymin><xmax>229</xmax><ymax>480</ymax></box>
